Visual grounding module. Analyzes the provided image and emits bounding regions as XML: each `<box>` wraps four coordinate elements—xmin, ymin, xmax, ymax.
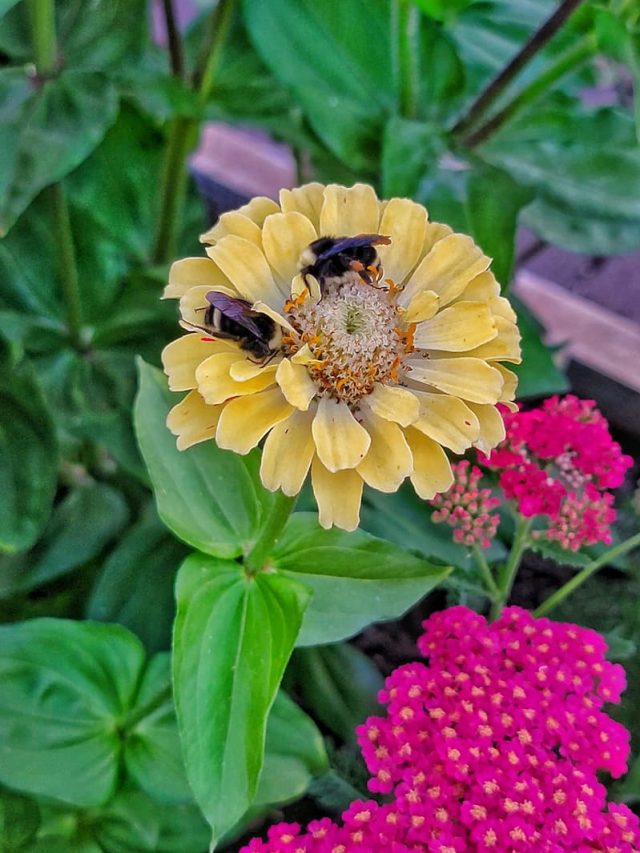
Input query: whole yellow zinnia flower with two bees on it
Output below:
<box><xmin>163</xmin><ymin>183</ymin><xmax>520</xmax><ymax>530</ymax></box>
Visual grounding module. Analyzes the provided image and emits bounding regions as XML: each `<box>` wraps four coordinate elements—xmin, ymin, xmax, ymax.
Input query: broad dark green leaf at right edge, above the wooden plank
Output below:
<box><xmin>481</xmin><ymin>105</ymin><xmax>640</xmax><ymax>255</ymax></box>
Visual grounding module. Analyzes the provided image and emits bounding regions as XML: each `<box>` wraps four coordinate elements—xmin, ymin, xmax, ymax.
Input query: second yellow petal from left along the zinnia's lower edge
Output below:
<box><xmin>216</xmin><ymin>388</ymin><xmax>294</xmax><ymax>454</ymax></box>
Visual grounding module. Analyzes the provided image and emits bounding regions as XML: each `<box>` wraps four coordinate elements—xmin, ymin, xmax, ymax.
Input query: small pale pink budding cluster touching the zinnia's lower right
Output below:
<box><xmin>429</xmin><ymin>459</ymin><xmax>500</xmax><ymax>548</ymax></box>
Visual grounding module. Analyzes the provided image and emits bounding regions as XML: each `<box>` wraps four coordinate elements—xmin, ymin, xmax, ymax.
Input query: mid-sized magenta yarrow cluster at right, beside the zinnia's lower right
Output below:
<box><xmin>479</xmin><ymin>395</ymin><xmax>632</xmax><ymax>551</ymax></box>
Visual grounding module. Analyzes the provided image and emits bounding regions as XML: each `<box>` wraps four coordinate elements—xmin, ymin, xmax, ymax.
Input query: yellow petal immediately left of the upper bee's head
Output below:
<box><xmin>262</xmin><ymin>212</ymin><xmax>318</xmax><ymax>294</ymax></box>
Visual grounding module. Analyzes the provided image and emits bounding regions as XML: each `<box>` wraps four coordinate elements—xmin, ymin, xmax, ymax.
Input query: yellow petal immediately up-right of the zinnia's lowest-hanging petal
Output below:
<box><xmin>356</xmin><ymin>414</ymin><xmax>413</xmax><ymax>492</ymax></box>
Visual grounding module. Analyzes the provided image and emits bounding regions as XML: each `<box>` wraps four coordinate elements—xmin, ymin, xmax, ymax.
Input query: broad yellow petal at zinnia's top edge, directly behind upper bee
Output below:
<box><xmin>318</xmin><ymin>184</ymin><xmax>380</xmax><ymax>237</ymax></box>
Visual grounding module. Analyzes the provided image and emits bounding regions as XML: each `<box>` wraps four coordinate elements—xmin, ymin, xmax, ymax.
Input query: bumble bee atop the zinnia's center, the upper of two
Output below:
<box><xmin>300</xmin><ymin>234</ymin><xmax>391</xmax><ymax>288</ymax></box>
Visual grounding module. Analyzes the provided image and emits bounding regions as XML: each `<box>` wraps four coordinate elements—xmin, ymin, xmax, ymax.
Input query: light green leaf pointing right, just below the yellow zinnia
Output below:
<box><xmin>272</xmin><ymin>512</ymin><xmax>450</xmax><ymax>646</ymax></box>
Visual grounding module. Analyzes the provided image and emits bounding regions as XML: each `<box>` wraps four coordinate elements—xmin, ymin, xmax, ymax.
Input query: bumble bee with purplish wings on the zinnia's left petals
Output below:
<box><xmin>188</xmin><ymin>290</ymin><xmax>281</xmax><ymax>363</ymax></box>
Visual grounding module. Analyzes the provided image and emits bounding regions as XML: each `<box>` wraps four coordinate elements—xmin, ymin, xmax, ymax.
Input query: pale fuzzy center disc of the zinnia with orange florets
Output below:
<box><xmin>287</xmin><ymin>274</ymin><xmax>407</xmax><ymax>408</ymax></box>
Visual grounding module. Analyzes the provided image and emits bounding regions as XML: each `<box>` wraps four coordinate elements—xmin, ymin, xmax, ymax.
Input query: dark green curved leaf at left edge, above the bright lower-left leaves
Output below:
<box><xmin>0</xmin><ymin>481</ymin><xmax>129</xmax><ymax>598</ymax></box>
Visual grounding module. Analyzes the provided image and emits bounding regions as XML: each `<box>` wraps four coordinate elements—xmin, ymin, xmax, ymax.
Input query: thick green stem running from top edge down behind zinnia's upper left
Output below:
<box><xmin>151</xmin><ymin>0</ymin><xmax>236</xmax><ymax>264</ymax></box>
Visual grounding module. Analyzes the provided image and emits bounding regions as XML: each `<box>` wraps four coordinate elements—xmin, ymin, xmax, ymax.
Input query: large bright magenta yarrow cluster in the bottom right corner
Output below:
<box><xmin>241</xmin><ymin>607</ymin><xmax>640</xmax><ymax>853</ymax></box>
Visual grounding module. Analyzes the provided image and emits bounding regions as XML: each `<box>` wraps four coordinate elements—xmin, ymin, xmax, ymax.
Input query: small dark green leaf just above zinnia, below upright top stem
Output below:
<box><xmin>382</xmin><ymin>116</ymin><xmax>444</xmax><ymax>198</ymax></box>
